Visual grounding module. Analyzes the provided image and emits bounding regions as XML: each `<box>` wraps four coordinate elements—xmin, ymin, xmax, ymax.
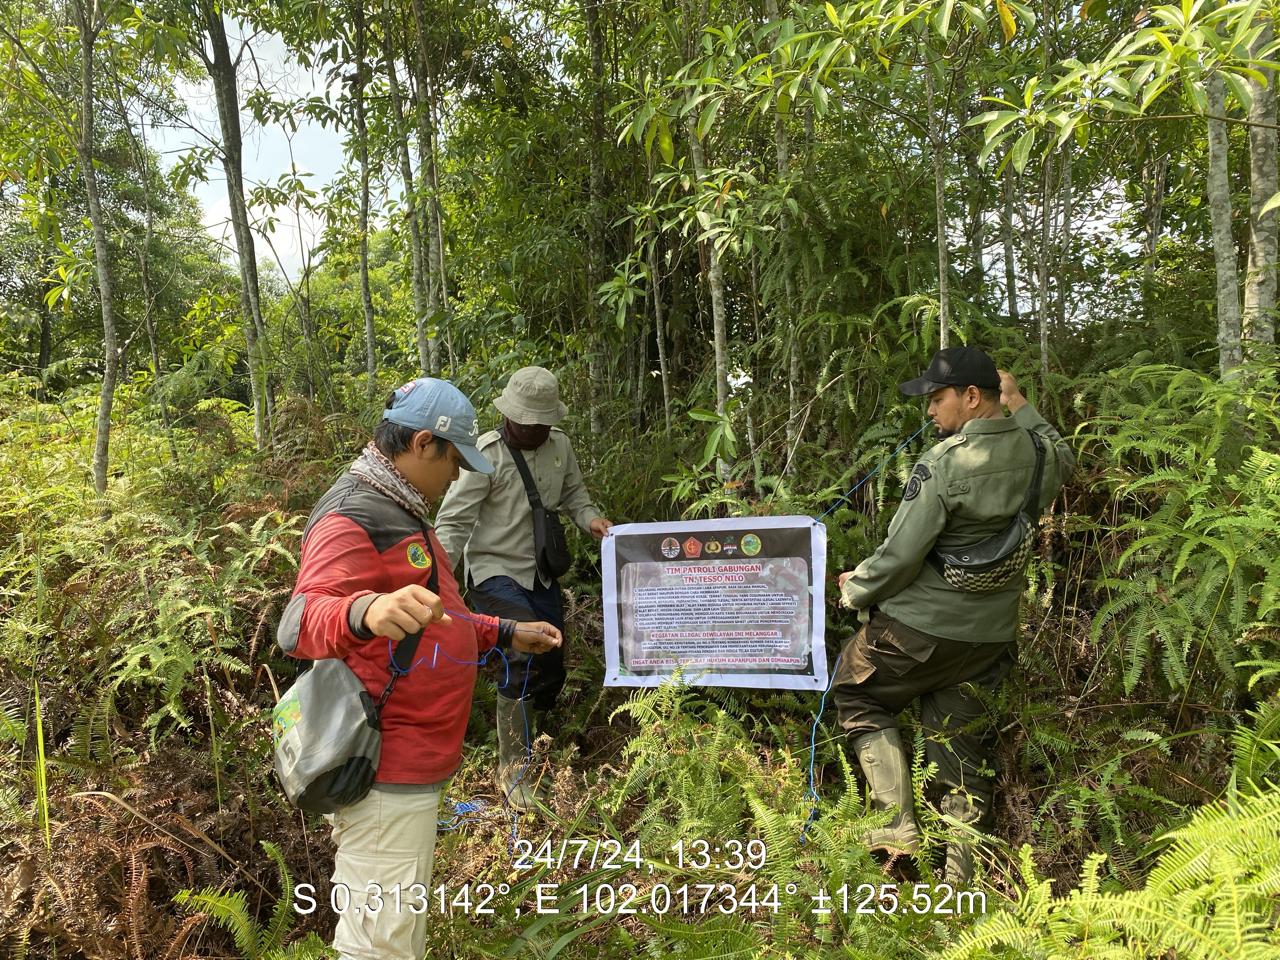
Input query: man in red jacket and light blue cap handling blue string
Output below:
<box><xmin>278</xmin><ymin>378</ymin><xmax>561</xmax><ymax>960</ymax></box>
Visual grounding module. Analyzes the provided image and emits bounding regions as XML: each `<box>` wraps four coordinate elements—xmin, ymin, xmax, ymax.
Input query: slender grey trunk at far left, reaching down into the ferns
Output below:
<box><xmin>72</xmin><ymin>7</ymin><xmax>120</xmax><ymax>495</ymax></box>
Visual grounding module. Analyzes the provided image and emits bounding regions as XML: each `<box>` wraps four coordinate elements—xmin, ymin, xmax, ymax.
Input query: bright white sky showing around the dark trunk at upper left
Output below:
<box><xmin>148</xmin><ymin>22</ymin><xmax>342</xmax><ymax>278</ymax></box>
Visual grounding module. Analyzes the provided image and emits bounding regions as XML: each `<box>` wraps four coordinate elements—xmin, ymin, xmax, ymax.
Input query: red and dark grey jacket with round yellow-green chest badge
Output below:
<box><xmin>276</xmin><ymin>474</ymin><xmax>498</xmax><ymax>783</ymax></box>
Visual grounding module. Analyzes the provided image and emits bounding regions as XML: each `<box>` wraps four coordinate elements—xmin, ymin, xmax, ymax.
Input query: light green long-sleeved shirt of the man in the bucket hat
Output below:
<box><xmin>435</xmin><ymin>426</ymin><xmax>600</xmax><ymax>590</ymax></box>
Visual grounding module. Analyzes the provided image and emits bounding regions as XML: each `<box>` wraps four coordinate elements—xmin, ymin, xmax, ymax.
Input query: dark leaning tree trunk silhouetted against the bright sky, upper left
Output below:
<box><xmin>200</xmin><ymin>0</ymin><xmax>274</xmax><ymax>448</ymax></box>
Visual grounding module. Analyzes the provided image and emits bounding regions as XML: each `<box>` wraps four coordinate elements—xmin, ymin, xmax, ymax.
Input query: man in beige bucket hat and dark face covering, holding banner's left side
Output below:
<box><xmin>435</xmin><ymin>366</ymin><xmax>612</xmax><ymax>810</ymax></box>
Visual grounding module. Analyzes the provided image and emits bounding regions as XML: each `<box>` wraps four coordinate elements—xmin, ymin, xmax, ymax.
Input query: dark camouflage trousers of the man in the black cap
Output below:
<box><xmin>831</xmin><ymin>611</ymin><xmax>1016</xmax><ymax>810</ymax></box>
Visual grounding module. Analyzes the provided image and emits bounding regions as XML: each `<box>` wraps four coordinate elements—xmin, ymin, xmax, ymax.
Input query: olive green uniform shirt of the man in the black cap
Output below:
<box><xmin>842</xmin><ymin>403</ymin><xmax>1075</xmax><ymax>643</ymax></box>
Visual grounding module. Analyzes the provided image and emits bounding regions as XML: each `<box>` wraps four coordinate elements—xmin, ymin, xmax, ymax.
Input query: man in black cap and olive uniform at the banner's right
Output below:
<box><xmin>832</xmin><ymin>347</ymin><xmax>1074</xmax><ymax>884</ymax></box>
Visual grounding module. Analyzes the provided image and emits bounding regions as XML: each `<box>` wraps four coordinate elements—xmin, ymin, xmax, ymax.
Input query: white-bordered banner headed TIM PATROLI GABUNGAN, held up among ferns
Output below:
<box><xmin>602</xmin><ymin>517</ymin><xmax>827</xmax><ymax>690</ymax></box>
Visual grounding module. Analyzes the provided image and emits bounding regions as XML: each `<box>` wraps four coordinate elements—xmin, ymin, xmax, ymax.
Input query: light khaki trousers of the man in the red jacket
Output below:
<box><xmin>332</xmin><ymin>785</ymin><xmax>444</xmax><ymax>960</ymax></box>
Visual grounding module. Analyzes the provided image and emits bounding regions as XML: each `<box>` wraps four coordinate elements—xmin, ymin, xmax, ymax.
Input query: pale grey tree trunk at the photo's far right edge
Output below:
<box><xmin>1242</xmin><ymin>23</ymin><xmax>1276</xmax><ymax>343</ymax></box>
